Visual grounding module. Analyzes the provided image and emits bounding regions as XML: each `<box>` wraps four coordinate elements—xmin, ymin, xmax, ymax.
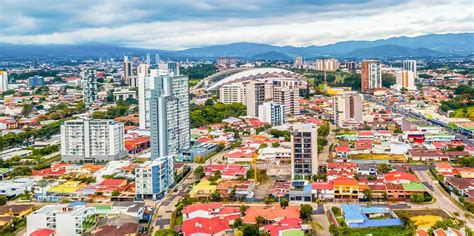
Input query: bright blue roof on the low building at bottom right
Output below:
<box><xmin>341</xmin><ymin>204</ymin><xmax>403</xmax><ymax>228</ymax></box>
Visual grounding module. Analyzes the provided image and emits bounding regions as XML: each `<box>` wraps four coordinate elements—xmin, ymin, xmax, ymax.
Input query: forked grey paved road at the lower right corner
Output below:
<box><xmin>412</xmin><ymin>170</ymin><xmax>474</xmax><ymax>229</ymax></box>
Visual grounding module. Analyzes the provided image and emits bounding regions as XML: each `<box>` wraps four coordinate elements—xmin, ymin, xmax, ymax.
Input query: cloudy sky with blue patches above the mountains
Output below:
<box><xmin>0</xmin><ymin>0</ymin><xmax>474</xmax><ymax>49</ymax></box>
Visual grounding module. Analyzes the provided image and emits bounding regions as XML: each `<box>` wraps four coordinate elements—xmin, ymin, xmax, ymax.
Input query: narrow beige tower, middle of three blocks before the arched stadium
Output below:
<box><xmin>245</xmin><ymin>81</ymin><xmax>265</xmax><ymax>117</ymax></box>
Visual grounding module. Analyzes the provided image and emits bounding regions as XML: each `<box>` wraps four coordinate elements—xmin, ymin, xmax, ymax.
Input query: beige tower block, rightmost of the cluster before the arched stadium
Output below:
<box><xmin>273</xmin><ymin>87</ymin><xmax>300</xmax><ymax>116</ymax></box>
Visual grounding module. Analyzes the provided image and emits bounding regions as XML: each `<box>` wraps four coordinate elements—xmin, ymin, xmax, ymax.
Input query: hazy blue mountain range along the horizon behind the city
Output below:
<box><xmin>0</xmin><ymin>33</ymin><xmax>474</xmax><ymax>60</ymax></box>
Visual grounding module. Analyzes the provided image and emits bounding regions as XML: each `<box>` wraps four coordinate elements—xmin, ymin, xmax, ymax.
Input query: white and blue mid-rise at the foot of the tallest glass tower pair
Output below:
<box><xmin>135</xmin><ymin>156</ymin><xmax>175</xmax><ymax>200</ymax></box>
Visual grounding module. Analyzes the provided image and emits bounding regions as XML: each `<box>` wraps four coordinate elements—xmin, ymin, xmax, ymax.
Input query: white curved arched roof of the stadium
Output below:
<box><xmin>207</xmin><ymin>68</ymin><xmax>300</xmax><ymax>90</ymax></box>
